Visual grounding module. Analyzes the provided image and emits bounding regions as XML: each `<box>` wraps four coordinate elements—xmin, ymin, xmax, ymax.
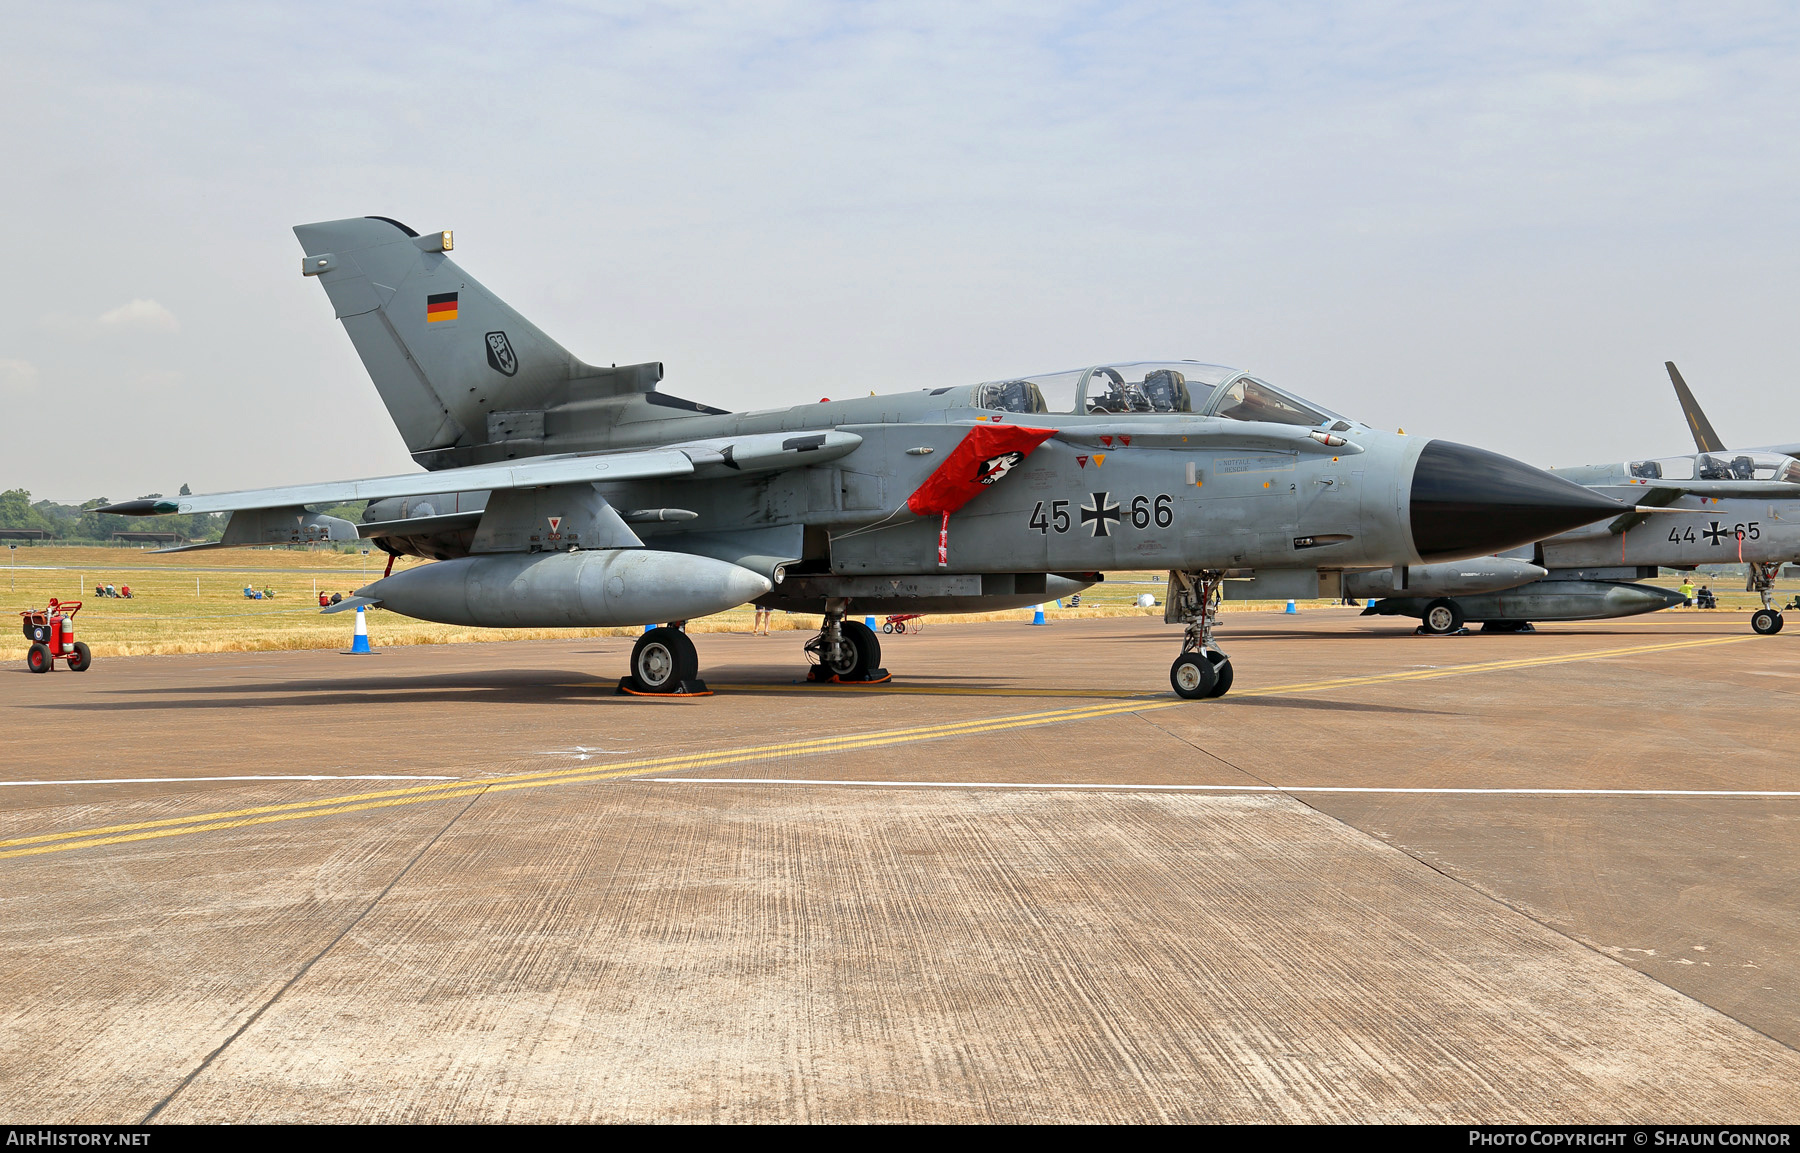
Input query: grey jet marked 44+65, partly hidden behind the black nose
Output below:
<box><xmin>1345</xmin><ymin>363</ymin><xmax>1800</xmax><ymax>635</ymax></box>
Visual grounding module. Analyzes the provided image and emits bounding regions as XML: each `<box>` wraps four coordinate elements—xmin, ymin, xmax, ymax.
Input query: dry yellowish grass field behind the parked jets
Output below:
<box><xmin>0</xmin><ymin>545</ymin><xmax>1793</xmax><ymax>660</ymax></box>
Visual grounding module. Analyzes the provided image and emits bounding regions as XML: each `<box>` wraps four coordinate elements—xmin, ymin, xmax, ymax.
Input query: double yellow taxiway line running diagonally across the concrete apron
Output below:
<box><xmin>0</xmin><ymin>635</ymin><xmax>1753</xmax><ymax>860</ymax></box>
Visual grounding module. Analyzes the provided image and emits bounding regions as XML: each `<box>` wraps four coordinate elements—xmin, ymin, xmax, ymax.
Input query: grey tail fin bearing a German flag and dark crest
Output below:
<box><xmin>293</xmin><ymin>216</ymin><xmax>661</xmax><ymax>468</ymax></box>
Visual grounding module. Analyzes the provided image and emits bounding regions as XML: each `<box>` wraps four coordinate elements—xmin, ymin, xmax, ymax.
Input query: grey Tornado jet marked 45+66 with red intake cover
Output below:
<box><xmin>110</xmin><ymin>218</ymin><xmax>1629</xmax><ymax>698</ymax></box>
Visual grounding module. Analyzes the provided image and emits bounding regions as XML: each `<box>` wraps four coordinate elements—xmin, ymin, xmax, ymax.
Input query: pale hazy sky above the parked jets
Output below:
<box><xmin>0</xmin><ymin>0</ymin><xmax>1800</xmax><ymax>500</ymax></box>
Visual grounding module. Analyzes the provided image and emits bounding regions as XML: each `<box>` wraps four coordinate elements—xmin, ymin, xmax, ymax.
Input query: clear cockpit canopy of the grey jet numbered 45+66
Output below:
<box><xmin>972</xmin><ymin>360</ymin><xmax>1350</xmax><ymax>432</ymax></box>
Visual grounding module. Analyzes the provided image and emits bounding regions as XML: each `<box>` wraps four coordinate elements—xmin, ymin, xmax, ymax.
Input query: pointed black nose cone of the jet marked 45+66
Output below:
<box><xmin>1411</xmin><ymin>441</ymin><xmax>1627</xmax><ymax>561</ymax></box>
